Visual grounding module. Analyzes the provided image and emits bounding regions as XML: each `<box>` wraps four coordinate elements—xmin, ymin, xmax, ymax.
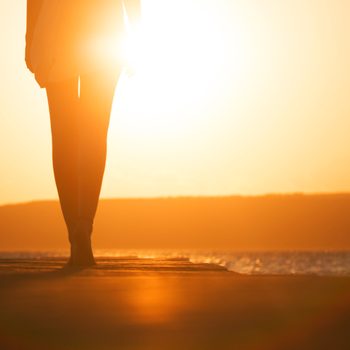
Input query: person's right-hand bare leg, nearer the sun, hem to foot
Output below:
<box><xmin>71</xmin><ymin>70</ymin><xmax>119</xmax><ymax>265</ymax></box>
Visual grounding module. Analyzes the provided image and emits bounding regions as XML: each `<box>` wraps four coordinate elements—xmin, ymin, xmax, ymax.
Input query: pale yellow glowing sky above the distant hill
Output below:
<box><xmin>0</xmin><ymin>0</ymin><xmax>350</xmax><ymax>203</ymax></box>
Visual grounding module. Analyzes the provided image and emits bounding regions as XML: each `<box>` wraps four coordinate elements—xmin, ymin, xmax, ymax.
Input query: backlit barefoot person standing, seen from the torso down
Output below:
<box><xmin>25</xmin><ymin>0</ymin><xmax>141</xmax><ymax>266</ymax></box>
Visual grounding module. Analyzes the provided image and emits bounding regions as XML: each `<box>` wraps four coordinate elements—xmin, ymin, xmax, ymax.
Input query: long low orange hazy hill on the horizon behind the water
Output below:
<box><xmin>0</xmin><ymin>194</ymin><xmax>350</xmax><ymax>250</ymax></box>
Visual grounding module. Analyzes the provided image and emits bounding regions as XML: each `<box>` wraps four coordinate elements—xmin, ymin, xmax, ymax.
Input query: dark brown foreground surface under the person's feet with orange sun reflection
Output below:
<box><xmin>0</xmin><ymin>257</ymin><xmax>350</xmax><ymax>350</ymax></box>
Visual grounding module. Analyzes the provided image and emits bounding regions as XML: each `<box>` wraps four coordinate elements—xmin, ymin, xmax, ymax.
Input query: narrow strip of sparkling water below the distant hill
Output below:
<box><xmin>0</xmin><ymin>249</ymin><xmax>350</xmax><ymax>276</ymax></box>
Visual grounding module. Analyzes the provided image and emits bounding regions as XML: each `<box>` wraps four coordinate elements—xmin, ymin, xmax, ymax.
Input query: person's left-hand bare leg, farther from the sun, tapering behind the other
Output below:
<box><xmin>46</xmin><ymin>77</ymin><xmax>79</xmax><ymax>238</ymax></box>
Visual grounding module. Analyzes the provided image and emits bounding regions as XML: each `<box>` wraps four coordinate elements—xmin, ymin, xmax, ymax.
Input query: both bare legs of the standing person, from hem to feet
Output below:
<box><xmin>46</xmin><ymin>67</ymin><xmax>119</xmax><ymax>265</ymax></box>
